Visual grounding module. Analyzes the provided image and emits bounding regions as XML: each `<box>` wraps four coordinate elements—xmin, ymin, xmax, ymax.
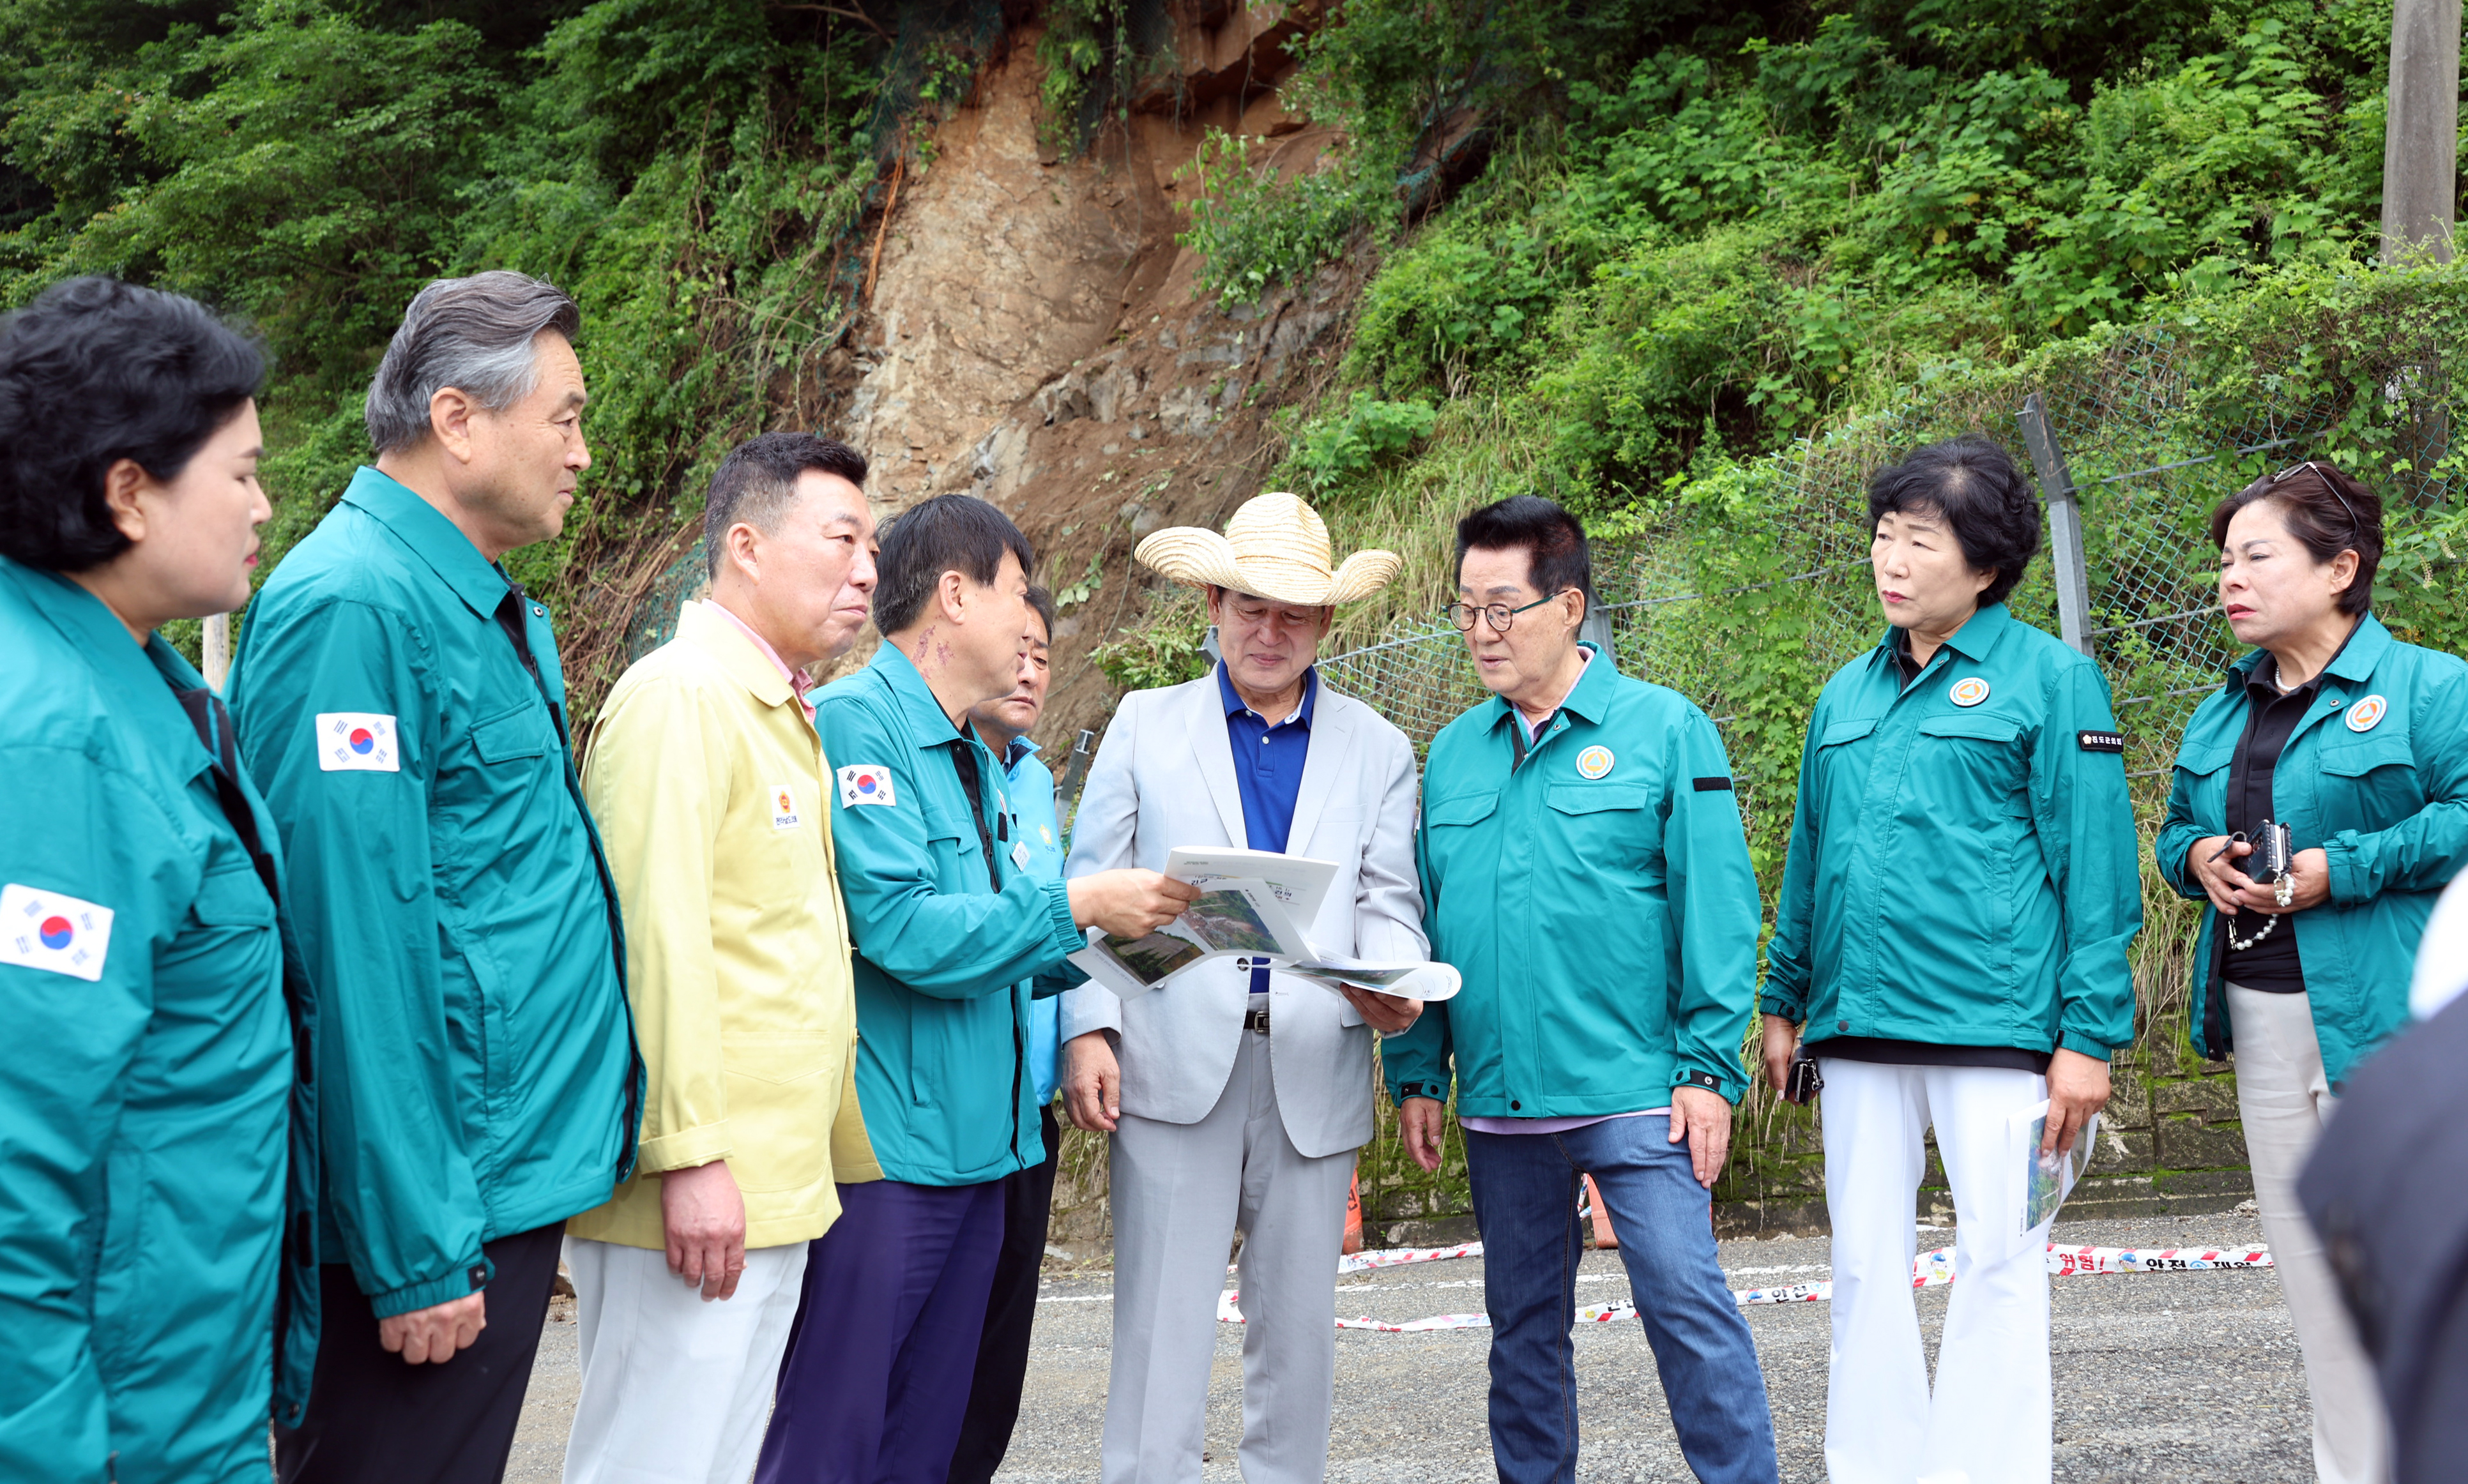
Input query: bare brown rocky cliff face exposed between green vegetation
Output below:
<box><xmin>834</xmin><ymin>0</ymin><xmax>1357</xmax><ymax>748</ymax></box>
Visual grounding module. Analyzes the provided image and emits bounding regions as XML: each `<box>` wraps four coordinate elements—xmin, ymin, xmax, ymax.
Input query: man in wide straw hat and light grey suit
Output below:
<box><xmin>1063</xmin><ymin>494</ymin><xmax>1426</xmax><ymax>1484</ymax></box>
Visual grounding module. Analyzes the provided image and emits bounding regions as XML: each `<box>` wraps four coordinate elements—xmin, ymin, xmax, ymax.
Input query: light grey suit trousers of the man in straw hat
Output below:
<box><xmin>1098</xmin><ymin>1029</ymin><xmax>1355</xmax><ymax>1484</ymax></box>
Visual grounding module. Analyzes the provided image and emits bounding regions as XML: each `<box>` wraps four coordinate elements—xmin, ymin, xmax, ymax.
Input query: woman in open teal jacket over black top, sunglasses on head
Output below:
<box><xmin>2154</xmin><ymin>462</ymin><xmax>2468</xmax><ymax>1484</ymax></box>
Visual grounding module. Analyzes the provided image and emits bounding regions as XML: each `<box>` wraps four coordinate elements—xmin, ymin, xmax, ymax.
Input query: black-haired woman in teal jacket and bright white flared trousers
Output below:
<box><xmin>1760</xmin><ymin>437</ymin><xmax>2142</xmax><ymax>1484</ymax></box>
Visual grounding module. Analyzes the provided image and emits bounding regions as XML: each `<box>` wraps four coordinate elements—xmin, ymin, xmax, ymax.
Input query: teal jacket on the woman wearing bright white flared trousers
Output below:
<box><xmin>1760</xmin><ymin>603</ymin><xmax>2142</xmax><ymax>1059</ymax></box>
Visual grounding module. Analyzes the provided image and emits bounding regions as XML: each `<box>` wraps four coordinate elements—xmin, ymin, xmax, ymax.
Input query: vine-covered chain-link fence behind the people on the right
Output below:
<box><xmin>1320</xmin><ymin>331</ymin><xmax>2458</xmax><ymax>1239</ymax></box>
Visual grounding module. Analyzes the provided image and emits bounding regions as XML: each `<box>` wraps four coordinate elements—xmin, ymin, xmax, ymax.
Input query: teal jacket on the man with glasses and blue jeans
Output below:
<box><xmin>1380</xmin><ymin>652</ymin><xmax>1760</xmax><ymax>1119</ymax></box>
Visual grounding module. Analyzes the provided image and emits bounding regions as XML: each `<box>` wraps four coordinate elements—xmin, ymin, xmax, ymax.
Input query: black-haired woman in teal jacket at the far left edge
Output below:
<box><xmin>0</xmin><ymin>279</ymin><xmax>316</xmax><ymax>1484</ymax></box>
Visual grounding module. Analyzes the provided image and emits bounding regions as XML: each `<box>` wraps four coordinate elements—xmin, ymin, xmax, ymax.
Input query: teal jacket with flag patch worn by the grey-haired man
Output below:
<box><xmin>232</xmin><ymin>469</ymin><xmax>642</xmax><ymax>1319</ymax></box>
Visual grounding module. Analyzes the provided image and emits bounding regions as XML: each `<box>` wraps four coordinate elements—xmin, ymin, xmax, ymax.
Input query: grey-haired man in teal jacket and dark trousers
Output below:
<box><xmin>229</xmin><ymin>271</ymin><xmax>642</xmax><ymax>1484</ymax></box>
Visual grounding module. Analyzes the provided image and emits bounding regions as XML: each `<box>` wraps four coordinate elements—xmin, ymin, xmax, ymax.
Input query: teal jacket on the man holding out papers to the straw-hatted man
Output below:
<box><xmin>814</xmin><ymin>644</ymin><xmax>1088</xmax><ymax>1185</ymax></box>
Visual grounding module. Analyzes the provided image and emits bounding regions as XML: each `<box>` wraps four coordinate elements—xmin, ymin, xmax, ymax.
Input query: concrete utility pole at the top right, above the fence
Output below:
<box><xmin>2382</xmin><ymin>0</ymin><xmax>2460</xmax><ymax>262</ymax></box>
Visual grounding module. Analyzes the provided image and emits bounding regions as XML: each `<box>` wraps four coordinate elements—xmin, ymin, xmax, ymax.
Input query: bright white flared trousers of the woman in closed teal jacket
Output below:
<box><xmin>1817</xmin><ymin>1045</ymin><xmax>2056</xmax><ymax>1484</ymax></box>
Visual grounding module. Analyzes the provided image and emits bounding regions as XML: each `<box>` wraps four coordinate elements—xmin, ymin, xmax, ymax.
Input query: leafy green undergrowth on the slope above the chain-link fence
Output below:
<box><xmin>1244</xmin><ymin>0</ymin><xmax>2389</xmax><ymax>499</ymax></box>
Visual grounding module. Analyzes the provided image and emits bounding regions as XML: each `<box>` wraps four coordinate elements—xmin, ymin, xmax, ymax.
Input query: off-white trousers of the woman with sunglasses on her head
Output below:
<box><xmin>2228</xmin><ymin>985</ymin><xmax>2391</xmax><ymax>1484</ymax></box>
